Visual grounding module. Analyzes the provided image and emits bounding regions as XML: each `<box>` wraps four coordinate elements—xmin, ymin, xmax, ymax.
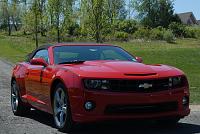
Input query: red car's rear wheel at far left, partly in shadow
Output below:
<box><xmin>11</xmin><ymin>80</ymin><xmax>30</xmax><ymax>116</ymax></box>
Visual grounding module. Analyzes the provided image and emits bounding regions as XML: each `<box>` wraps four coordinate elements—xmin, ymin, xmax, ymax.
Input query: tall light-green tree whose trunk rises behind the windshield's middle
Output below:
<box><xmin>81</xmin><ymin>0</ymin><xmax>108</xmax><ymax>43</ymax></box>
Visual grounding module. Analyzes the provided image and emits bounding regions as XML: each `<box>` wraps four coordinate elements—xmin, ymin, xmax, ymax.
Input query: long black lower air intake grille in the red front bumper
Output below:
<box><xmin>104</xmin><ymin>102</ymin><xmax>178</xmax><ymax>115</ymax></box>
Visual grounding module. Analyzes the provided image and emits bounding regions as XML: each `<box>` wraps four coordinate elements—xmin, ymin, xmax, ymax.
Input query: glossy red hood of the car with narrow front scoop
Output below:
<box><xmin>59</xmin><ymin>61</ymin><xmax>183</xmax><ymax>78</ymax></box>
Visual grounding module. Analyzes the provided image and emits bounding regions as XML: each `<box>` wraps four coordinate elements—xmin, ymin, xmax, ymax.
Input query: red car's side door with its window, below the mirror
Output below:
<box><xmin>25</xmin><ymin>49</ymin><xmax>49</xmax><ymax>110</ymax></box>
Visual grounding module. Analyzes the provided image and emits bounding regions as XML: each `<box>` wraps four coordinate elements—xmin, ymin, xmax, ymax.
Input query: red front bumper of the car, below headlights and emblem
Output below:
<box><xmin>70</xmin><ymin>88</ymin><xmax>190</xmax><ymax>123</ymax></box>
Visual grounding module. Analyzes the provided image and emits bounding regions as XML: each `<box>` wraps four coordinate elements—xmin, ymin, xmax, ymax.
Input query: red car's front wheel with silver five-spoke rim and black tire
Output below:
<box><xmin>53</xmin><ymin>83</ymin><xmax>73</xmax><ymax>132</ymax></box>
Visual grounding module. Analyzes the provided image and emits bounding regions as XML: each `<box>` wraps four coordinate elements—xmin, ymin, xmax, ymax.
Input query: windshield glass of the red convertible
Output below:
<box><xmin>53</xmin><ymin>46</ymin><xmax>136</xmax><ymax>64</ymax></box>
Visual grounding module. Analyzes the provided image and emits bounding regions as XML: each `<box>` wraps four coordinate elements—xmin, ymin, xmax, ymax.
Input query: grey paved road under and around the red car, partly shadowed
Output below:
<box><xmin>0</xmin><ymin>60</ymin><xmax>200</xmax><ymax>134</ymax></box>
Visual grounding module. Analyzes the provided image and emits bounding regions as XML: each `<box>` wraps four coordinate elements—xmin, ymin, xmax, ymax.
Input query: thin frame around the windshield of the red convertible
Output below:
<box><xmin>52</xmin><ymin>44</ymin><xmax>138</xmax><ymax>65</ymax></box>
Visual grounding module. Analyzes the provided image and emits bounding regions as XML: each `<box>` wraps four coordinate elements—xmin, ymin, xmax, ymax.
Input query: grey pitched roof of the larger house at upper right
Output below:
<box><xmin>178</xmin><ymin>12</ymin><xmax>197</xmax><ymax>24</ymax></box>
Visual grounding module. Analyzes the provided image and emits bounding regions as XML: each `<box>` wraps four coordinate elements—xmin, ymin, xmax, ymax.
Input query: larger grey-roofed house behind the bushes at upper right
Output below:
<box><xmin>178</xmin><ymin>12</ymin><xmax>199</xmax><ymax>25</ymax></box>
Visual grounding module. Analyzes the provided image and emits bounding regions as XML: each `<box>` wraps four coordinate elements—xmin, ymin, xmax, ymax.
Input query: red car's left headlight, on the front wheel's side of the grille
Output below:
<box><xmin>84</xmin><ymin>79</ymin><xmax>110</xmax><ymax>90</ymax></box>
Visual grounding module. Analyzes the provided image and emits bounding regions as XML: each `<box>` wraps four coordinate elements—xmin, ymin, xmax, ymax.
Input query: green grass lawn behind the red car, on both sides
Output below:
<box><xmin>0</xmin><ymin>35</ymin><xmax>200</xmax><ymax>104</ymax></box>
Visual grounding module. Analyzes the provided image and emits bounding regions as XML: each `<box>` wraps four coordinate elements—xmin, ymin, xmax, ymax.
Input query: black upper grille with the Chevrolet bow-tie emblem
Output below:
<box><xmin>110</xmin><ymin>78</ymin><xmax>170</xmax><ymax>93</ymax></box>
